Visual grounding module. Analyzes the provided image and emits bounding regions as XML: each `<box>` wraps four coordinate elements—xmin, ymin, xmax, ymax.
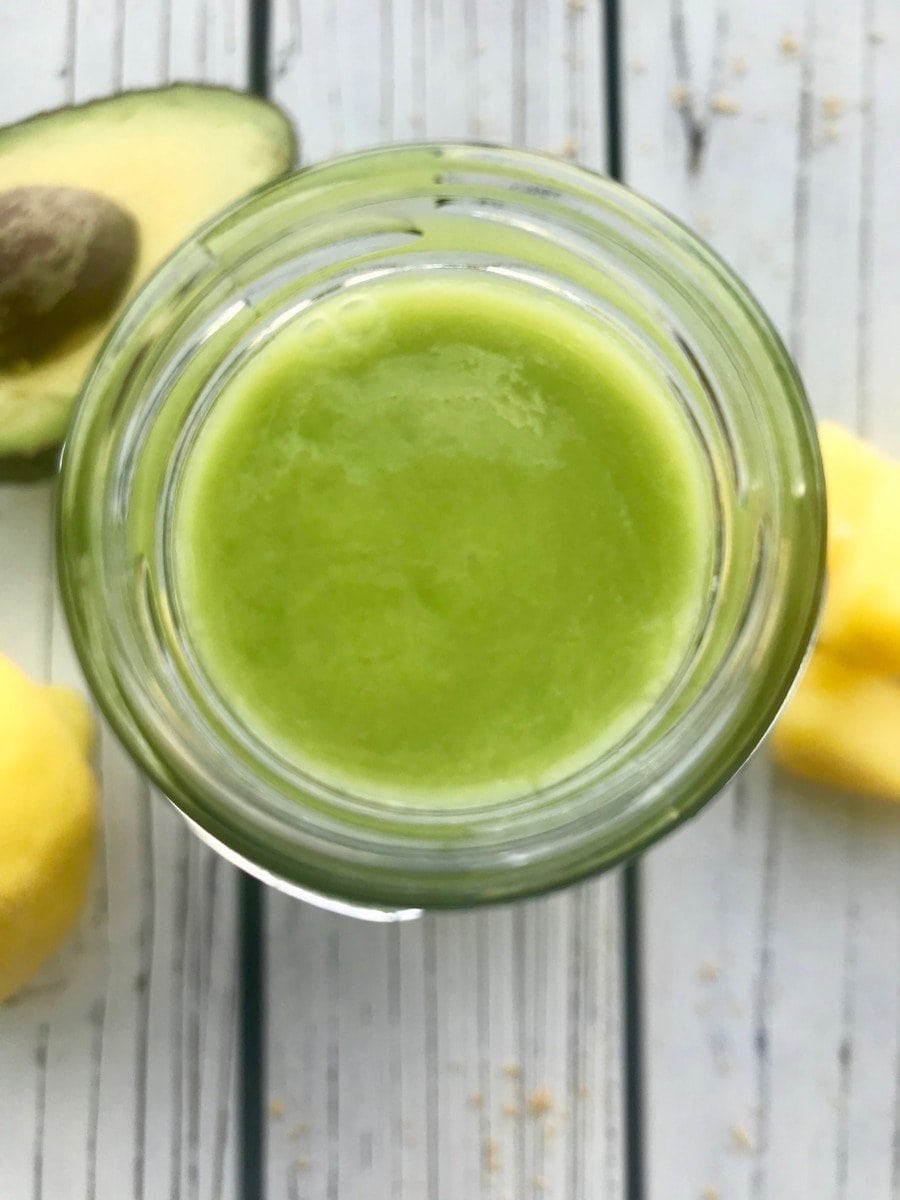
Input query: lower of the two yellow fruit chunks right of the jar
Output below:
<box><xmin>772</xmin><ymin>648</ymin><xmax>900</xmax><ymax>800</ymax></box>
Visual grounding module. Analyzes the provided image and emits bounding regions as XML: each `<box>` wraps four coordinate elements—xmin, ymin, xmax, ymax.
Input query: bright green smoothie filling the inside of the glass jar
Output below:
<box><xmin>174</xmin><ymin>270</ymin><xmax>713</xmax><ymax>805</ymax></box>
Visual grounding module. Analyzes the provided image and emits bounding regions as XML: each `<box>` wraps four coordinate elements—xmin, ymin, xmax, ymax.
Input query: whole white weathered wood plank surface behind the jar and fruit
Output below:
<box><xmin>0</xmin><ymin>0</ymin><xmax>900</xmax><ymax>1200</ymax></box>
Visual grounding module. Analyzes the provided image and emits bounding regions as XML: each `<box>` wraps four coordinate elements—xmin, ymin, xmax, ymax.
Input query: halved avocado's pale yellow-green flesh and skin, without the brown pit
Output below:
<box><xmin>0</xmin><ymin>84</ymin><xmax>296</xmax><ymax>465</ymax></box>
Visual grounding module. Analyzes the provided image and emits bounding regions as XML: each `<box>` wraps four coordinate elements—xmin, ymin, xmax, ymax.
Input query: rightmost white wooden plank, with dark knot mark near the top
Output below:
<box><xmin>625</xmin><ymin>0</ymin><xmax>900</xmax><ymax>1200</ymax></box>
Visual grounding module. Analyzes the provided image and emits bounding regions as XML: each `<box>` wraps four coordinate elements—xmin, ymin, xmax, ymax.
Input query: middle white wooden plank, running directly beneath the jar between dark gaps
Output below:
<box><xmin>268</xmin><ymin>0</ymin><xmax>623</xmax><ymax>1200</ymax></box>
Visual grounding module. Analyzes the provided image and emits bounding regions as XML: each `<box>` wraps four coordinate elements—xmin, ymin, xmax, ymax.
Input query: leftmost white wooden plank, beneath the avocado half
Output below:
<box><xmin>0</xmin><ymin>0</ymin><xmax>247</xmax><ymax>1200</ymax></box>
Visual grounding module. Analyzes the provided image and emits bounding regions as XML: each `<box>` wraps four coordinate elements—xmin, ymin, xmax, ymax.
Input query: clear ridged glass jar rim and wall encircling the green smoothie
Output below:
<box><xmin>59</xmin><ymin>145</ymin><xmax>824</xmax><ymax>917</ymax></box>
